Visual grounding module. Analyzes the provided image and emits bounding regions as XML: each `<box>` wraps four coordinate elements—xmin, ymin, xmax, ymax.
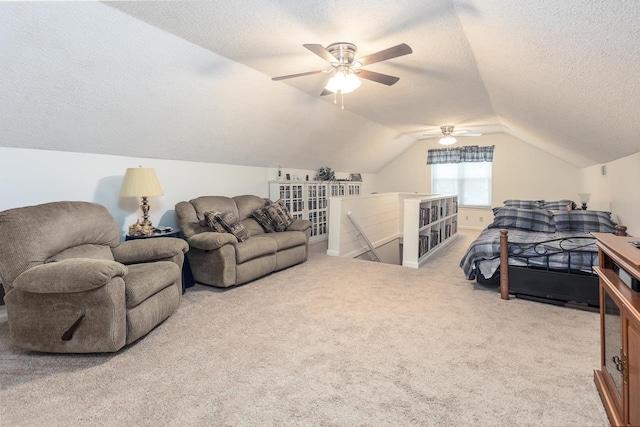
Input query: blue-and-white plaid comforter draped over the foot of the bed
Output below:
<box><xmin>460</xmin><ymin>228</ymin><xmax>598</xmax><ymax>280</ymax></box>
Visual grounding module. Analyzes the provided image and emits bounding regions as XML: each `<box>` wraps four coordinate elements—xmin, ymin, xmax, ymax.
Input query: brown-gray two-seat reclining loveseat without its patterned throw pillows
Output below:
<box><xmin>176</xmin><ymin>195</ymin><xmax>311</xmax><ymax>287</ymax></box>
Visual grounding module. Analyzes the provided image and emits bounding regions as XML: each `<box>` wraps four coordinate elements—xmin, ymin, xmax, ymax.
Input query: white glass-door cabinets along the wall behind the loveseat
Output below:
<box><xmin>269</xmin><ymin>181</ymin><xmax>362</xmax><ymax>242</ymax></box>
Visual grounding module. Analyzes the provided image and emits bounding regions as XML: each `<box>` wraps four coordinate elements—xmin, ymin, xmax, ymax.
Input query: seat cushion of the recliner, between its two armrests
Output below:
<box><xmin>124</xmin><ymin>261</ymin><xmax>181</xmax><ymax>308</ymax></box>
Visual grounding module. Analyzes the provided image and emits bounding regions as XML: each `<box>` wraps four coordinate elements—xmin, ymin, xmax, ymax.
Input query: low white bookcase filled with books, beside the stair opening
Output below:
<box><xmin>402</xmin><ymin>194</ymin><xmax>458</xmax><ymax>268</ymax></box>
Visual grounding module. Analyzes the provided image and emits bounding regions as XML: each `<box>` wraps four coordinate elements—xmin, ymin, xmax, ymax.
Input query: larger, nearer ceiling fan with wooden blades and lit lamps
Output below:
<box><xmin>271</xmin><ymin>42</ymin><xmax>413</xmax><ymax>109</ymax></box>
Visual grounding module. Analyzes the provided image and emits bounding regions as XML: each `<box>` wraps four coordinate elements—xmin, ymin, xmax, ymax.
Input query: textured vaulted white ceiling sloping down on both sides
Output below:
<box><xmin>0</xmin><ymin>0</ymin><xmax>640</xmax><ymax>172</ymax></box>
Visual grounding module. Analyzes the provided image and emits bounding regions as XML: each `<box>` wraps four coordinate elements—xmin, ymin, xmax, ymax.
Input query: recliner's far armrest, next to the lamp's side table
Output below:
<box><xmin>112</xmin><ymin>237</ymin><xmax>189</xmax><ymax>264</ymax></box>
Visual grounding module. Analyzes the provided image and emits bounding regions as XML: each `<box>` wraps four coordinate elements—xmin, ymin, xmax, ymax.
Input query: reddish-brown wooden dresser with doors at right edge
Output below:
<box><xmin>593</xmin><ymin>233</ymin><xmax>640</xmax><ymax>426</ymax></box>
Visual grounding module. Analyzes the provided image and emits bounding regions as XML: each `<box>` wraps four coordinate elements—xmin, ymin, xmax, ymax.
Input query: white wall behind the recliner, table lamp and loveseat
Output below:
<box><xmin>0</xmin><ymin>147</ymin><xmax>371</xmax><ymax>239</ymax></box>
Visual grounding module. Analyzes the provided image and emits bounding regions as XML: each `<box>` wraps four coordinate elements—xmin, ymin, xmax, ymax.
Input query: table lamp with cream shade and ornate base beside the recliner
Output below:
<box><xmin>120</xmin><ymin>167</ymin><xmax>164</xmax><ymax>235</ymax></box>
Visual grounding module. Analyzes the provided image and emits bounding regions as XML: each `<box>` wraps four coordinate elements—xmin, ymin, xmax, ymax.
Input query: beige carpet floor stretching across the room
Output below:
<box><xmin>0</xmin><ymin>231</ymin><xmax>608</xmax><ymax>427</ymax></box>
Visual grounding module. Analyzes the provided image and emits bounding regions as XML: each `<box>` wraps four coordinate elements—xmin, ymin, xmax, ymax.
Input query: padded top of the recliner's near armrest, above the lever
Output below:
<box><xmin>12</xmin><ymin>258</ymin><xmax>128</xmax><ymax>294</ymax></box>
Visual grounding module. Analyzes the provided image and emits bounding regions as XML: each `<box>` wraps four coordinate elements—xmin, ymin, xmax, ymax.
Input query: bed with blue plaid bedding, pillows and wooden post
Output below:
<box><xmin>460</xmin><ymin>200</ymin><xmax>626</xmax><ymax>308</ymax></box>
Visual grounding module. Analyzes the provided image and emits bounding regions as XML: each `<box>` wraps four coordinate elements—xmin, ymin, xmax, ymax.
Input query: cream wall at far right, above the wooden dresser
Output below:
<box><xmin>581</xmin><ymin>152</ymin><xmax>640</xmax><ymax>236</ymax></box>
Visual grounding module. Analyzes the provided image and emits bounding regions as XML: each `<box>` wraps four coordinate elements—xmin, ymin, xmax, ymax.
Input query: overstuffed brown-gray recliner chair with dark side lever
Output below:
<box><xmin>0</xmin><ymin>202</ymin><xmax>188</xmax><ymax>353</ymax></box>
